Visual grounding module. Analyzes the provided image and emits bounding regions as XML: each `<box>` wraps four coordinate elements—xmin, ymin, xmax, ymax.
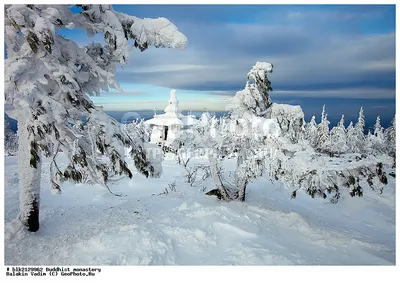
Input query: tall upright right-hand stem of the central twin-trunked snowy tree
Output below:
<box><xmin>223</xmin><ymin>62</ymin><xmax>280</xmax><ymax>201</ymax></box>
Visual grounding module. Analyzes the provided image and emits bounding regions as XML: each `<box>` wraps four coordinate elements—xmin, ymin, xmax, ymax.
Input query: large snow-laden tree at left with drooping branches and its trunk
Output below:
<box><xmin>4</xmin><ymin>5</ymin><xmax>186</xmax><ymax>231</ymax></box>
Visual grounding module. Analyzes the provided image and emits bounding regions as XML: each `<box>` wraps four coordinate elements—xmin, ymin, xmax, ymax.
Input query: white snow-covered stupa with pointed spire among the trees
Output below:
<box><xmin>145</xmin><ymin>89</ymin><xmax>198</xmax><ymax>146</ymax></box>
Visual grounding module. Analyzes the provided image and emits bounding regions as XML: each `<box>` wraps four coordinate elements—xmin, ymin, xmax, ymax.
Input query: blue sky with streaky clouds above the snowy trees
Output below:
<box><xmin>57</xmin><ymin>5</ymin><xmax>395</xmax><ymax>125</ymax></box>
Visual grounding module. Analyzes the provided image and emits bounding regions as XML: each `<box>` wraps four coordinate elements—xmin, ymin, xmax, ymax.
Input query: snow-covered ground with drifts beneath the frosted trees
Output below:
<box><xmin>5</xmin><ymin>157</ymin><xmax>395</xmax><ymax>265</ymax></box>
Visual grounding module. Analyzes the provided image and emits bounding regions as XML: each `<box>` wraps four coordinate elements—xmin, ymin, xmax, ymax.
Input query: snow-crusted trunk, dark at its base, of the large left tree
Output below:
<box><xmin>18</xmin><ymin>119</ymin><xmax>41</xmax><ymax>232</ymax></box>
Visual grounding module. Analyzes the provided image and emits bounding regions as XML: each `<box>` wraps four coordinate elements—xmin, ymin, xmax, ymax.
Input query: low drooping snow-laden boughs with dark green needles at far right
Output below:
<box><xmin>269</xmin><ymin>145</ymin><xmax>391</xmax><ymax>203</ymax></box>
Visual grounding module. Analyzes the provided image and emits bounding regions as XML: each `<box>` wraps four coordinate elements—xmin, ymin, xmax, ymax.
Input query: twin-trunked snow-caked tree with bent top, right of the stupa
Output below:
<box><xmin>176</xmin><ymin>62</ymin><xmax>279</xmax><ymax>201</ymax></box>
